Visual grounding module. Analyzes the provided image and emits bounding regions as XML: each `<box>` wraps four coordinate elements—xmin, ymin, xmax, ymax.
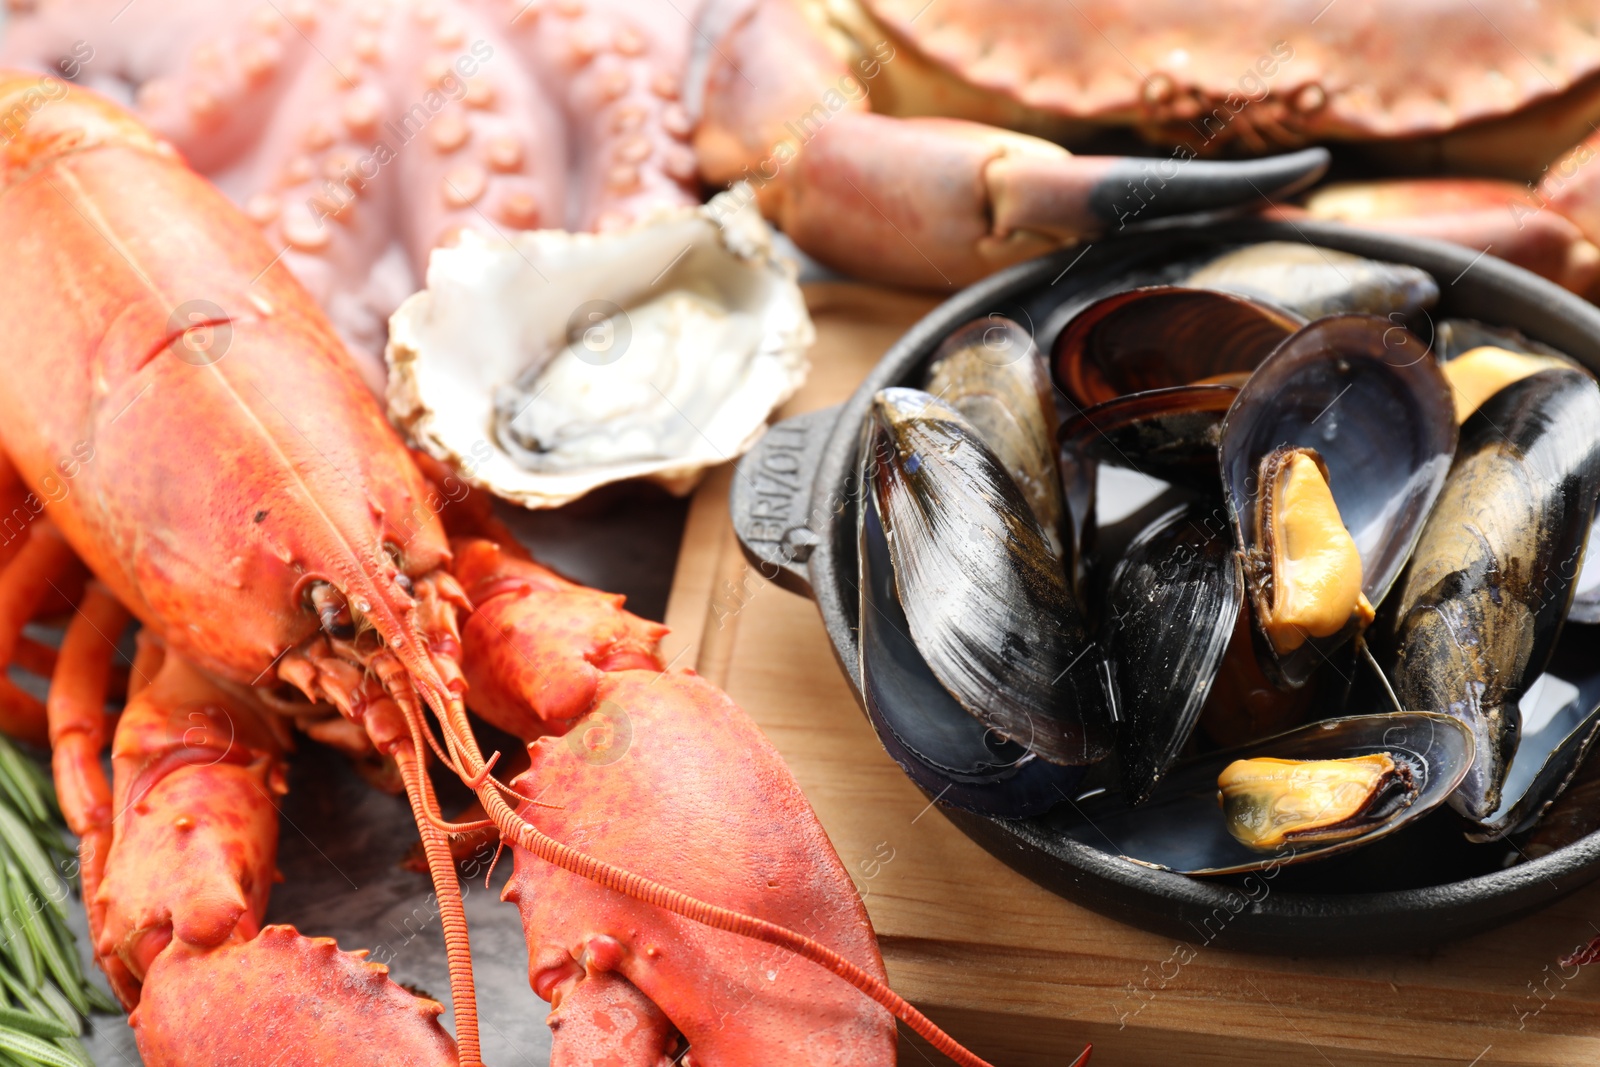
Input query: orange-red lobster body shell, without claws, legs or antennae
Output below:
<box><xmin>0</xmin><ymin>75</ymin><xmax>448</xmax><ymax>685</ymax></box>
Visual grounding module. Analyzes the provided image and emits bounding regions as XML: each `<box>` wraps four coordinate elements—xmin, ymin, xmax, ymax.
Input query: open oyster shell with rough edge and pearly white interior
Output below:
<box><xmin>387</xmin><ymin>190</ymin><xmax>814</xmax><ymax>507</ymax></box>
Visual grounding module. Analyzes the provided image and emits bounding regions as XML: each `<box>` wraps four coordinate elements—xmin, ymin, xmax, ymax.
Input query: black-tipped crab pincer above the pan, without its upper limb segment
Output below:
<box><xmin>773</xmin><ymin>114</ymin><xmax>1328</xmax><ymax>288</ymax></box>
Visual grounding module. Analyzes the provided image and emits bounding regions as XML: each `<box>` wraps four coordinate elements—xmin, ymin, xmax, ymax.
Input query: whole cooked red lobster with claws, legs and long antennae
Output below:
<box><xmin>0</xmin><ymin>72</ymin><xmax>1036</xmax><ymax>1067</ymax></box>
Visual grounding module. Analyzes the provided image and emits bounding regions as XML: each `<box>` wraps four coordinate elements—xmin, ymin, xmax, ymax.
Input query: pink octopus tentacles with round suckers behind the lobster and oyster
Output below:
<box><xmin>0</xmin><ymin>0</ymin><xmax>698</xmax><ymax>390</ymax></box>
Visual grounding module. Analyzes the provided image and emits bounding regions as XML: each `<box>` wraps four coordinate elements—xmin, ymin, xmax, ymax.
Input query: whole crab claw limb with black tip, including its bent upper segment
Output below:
<box><xmin>696</xmin><ymin>0</ymin><xmax>1328</xmax><ymax>288</ymax></box>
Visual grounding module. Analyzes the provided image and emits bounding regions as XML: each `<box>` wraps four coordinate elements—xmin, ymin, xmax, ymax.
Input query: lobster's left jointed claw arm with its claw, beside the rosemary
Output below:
<box><xmin>74</xmin><ymin>652</ymin><xmax>458</xmax><ymax>1067</ymax></box>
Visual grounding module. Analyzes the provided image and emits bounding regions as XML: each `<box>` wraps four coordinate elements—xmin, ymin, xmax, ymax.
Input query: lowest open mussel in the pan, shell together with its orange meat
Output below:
<box><xmin>1051</xmin><ymin>712</ymin><xmax>1472</xmax><ymax>875</ymax></box>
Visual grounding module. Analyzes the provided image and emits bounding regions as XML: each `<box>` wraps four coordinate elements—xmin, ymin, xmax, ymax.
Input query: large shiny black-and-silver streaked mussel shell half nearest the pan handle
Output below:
<box><xmin>864</xmin><ymin>389</ymin><xmax>1110</xmax><ymax>765</ymax></box>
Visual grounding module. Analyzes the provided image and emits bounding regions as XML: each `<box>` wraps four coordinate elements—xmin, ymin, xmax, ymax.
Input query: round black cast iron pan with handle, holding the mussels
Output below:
<box><xmin>731</xmin><ymin>221</ymin><xmax>1600</xmax><ymax>953</ymax></box>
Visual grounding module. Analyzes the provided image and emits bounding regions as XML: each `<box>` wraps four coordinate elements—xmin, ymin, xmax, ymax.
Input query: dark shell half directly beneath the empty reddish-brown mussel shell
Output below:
<box><xmin>1061</xmin><ymin>384</ymin><xmax>1238</xmax><ymax>491</ymax></box>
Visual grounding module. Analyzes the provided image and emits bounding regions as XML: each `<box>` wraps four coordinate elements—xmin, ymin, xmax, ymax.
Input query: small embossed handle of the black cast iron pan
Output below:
<box><xmin>728</xmin><ymin>405</ymin><xmax>842</xmax><ymax>597</ymax></box>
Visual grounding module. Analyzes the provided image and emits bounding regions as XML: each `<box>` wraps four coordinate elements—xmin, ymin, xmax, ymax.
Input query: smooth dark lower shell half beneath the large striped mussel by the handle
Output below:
<box><xmin>859</xmin><ymin>493</ymin><xmax>1085</xmax><ymax>819</ymax></box>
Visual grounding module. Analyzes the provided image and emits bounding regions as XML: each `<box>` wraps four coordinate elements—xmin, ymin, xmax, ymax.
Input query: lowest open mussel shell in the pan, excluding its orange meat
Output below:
<box><xmin>1056</xmin><ymin>712</ymin><xmax>1472</xmax><ymax>875</ymax></box>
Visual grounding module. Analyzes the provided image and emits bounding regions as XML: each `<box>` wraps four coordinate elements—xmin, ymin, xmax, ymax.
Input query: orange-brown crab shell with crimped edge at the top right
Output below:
<box><xmin>810</xmin><ymin>0</ymin><xmax>1600</xmax><ymax>174</ymax></box>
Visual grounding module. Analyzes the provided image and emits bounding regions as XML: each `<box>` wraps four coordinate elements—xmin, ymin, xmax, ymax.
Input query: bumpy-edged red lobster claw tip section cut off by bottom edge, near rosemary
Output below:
<box><xmin>131</xmin><ymin>926</ymin><xmax>456</xmax><ymax>1067</ymax></box>
